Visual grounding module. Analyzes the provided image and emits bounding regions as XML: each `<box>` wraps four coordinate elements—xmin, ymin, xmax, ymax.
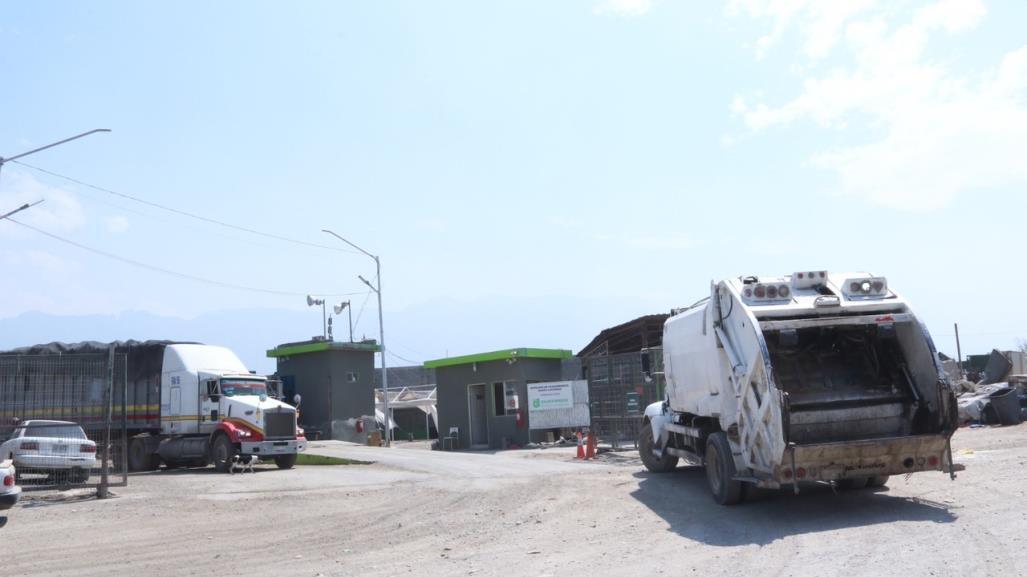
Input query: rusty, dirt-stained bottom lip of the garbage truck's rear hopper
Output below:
<box><xmin>774</xmin><ymin>434</ymin><xmax>953</xmax><ymax>483</ymax></box>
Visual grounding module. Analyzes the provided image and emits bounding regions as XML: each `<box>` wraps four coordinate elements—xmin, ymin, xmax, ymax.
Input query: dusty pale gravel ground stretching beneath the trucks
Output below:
<box><xmin>0</xmin><ymin>424</ymin><xmax>1027</xmax><ymax>577</ymax></box>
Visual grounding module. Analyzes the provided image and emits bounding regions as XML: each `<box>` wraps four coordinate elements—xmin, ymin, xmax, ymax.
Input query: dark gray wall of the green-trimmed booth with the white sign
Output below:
<box><xmin>435</xmin><ymin>358</ymin><xmax>563</xmax><ymax>449</ymax></box>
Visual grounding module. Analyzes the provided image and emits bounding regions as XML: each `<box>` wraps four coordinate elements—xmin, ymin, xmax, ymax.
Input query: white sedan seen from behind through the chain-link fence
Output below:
<box><xmin>0</xmin><ymin>420</ymin><xmax>97</xmax><ymax>483</ymax></box>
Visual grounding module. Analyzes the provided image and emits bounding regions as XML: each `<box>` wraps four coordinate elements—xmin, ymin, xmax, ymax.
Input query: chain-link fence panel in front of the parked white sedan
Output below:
<box><xmin>0</xmin><ymin>350</ymin><xmax>128</xmax><ymax>497</ymax></box>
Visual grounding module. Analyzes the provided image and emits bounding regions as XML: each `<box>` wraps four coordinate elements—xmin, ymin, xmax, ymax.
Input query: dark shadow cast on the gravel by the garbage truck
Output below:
<box><xmin>632</xmin><ymin>466</ymin><xmax>956</xmax><ymax>546</ymax></box>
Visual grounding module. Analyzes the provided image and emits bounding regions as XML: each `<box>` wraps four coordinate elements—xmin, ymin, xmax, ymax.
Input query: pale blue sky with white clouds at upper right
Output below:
<box><xmin>0</xmin><ymin>0</ymin><xmax>1027</xmax><ymax>363</ymax></box>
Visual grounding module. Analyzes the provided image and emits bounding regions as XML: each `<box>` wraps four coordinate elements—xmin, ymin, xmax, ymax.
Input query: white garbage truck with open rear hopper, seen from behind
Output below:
<box><xmin>639</xmin><ymin>271</ymin><xmax>957</xmax><ymax>505</ymax></box>
